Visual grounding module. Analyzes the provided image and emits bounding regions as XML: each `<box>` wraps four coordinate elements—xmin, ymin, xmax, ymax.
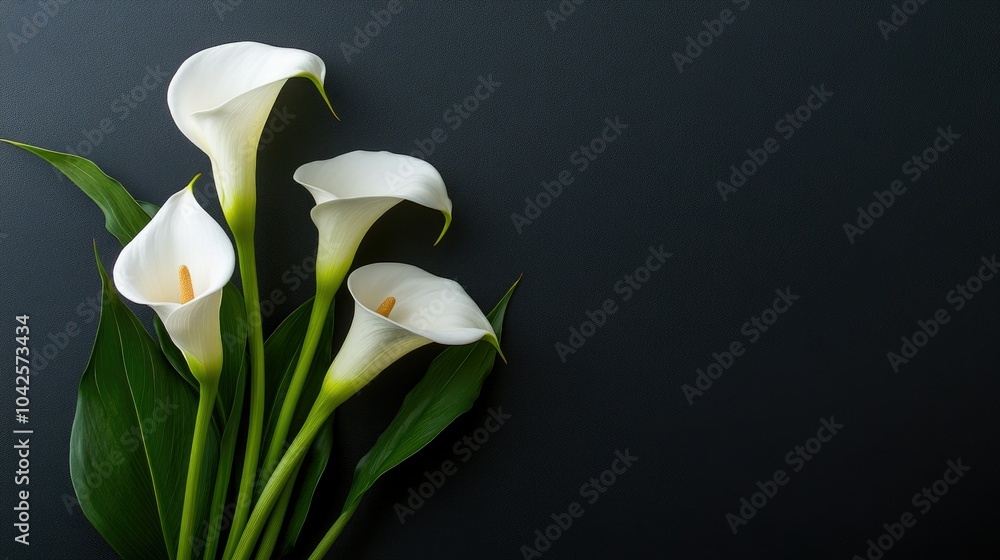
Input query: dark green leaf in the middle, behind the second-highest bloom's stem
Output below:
<box><xmin>261</xmin><ymin>298</ymin><xmax>333</xmax><ymax>551</ymax></box>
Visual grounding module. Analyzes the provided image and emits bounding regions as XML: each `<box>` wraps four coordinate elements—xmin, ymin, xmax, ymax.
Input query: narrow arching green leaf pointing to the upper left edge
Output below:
<box><xmin>0</xmin><ymin>140</ymin><xmax>150</xmax><ymax>245</ymax></box>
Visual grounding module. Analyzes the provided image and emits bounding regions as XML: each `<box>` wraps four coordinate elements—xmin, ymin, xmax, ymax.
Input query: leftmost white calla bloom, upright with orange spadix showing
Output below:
<box><xmin>114</xmin><ymin>177</ymin><xmax>236</xmax><ymax>382</ymax></box>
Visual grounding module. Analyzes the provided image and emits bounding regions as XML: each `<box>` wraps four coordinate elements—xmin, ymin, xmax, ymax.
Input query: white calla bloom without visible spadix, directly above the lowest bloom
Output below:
<box><xmin>294</xmin><ymin>151</ymin><xmax>452</xmax><ymax>286</ymax></box>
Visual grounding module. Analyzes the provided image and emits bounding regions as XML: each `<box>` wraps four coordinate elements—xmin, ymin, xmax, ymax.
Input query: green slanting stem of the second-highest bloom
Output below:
<box><xmin>260</xmin><ymin>287</ymin><xmax>336</xmax><ymax>482</ymax></box>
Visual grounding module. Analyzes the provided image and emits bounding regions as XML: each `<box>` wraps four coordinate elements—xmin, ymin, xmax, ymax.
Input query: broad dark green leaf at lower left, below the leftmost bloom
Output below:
<box><xmin>70</xmin><ymin>248</ymin><xmax>218</xmax><ymax>560</ymax></box>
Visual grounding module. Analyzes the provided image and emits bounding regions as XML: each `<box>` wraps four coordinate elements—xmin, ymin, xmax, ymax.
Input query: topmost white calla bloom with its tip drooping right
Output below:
<box><xmin>167</xmin><ymin>41</ymin><xmax>332</xmax><ymax>231</ymax></box>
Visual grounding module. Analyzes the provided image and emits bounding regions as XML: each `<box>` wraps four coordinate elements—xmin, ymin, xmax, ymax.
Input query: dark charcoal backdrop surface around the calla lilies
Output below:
<box><xmin>0</xmin><ymin>0</ymin><xmax>1000</xmax><ymax>560</ymax></box>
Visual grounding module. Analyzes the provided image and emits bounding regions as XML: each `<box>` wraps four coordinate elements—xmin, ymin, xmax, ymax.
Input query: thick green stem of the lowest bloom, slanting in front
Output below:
<box><xmin>233</xmin><ymin>393</ymin><xmax>343</xmax><ymax>560</ymax></box>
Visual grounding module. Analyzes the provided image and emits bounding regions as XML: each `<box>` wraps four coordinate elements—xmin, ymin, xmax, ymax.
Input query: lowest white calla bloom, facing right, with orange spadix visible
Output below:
<box><xmin>323</xmin><ymin>263</ymin><xmax>499</xmax><ymax>401</ymax></box>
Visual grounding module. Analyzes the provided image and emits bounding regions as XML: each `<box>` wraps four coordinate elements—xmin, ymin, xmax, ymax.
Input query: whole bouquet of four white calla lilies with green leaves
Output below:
<box><xmin>7</xmin><ymin>42</ymin><xmax>516</xmax><ymax>560</ymax></box>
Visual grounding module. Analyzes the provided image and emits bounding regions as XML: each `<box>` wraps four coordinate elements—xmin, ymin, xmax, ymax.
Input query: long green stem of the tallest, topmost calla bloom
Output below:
<box><xmin>223</xmin><ymin>233</ymin><xmax>264</xmax><ymax>560</ymax></box>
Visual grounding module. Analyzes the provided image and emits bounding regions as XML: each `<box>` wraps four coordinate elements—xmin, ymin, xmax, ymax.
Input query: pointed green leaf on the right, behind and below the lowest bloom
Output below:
<box><xmin>344</xmin><ymin>278</ymin><xmax>520</xmax><ymax>512</ymax></box>
